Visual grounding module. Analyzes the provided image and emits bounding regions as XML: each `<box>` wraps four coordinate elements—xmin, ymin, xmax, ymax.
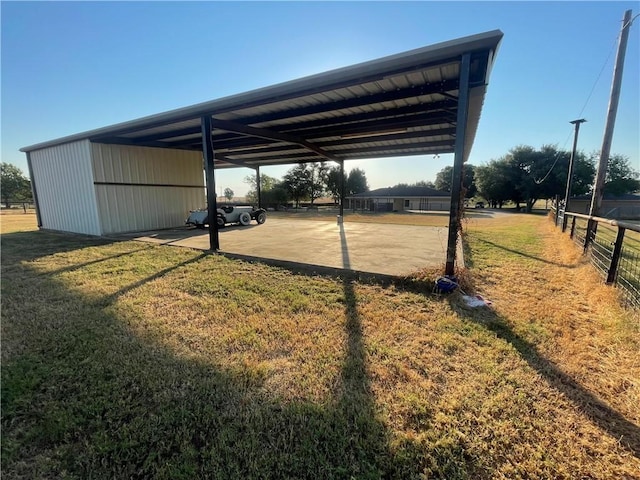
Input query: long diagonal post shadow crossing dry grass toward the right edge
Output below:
<box><xmin>449</xmin><ymin>297</ymin><xmax>640</xmax><ymax>458</ymax></box>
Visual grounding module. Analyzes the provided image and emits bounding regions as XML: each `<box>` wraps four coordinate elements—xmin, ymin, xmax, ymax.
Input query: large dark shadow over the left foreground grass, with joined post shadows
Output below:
<box><xmin>1</xmin><ymin>232</ymin><xmax>472</xmax><ymax>479</ymax></box>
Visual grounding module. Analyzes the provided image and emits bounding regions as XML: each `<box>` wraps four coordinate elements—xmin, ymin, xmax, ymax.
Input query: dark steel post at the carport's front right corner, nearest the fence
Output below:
<box><xmin>445</xmin><ymin>53</ymin><xmax>471</xmax><ymax>275</ymax></box>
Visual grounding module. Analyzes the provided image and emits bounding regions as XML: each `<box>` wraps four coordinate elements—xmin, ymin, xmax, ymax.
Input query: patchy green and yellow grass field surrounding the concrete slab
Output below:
<box><xmin>0</xmin><ymin>214</ymin><xmax>640</xmax><ymax>479</ymax></box>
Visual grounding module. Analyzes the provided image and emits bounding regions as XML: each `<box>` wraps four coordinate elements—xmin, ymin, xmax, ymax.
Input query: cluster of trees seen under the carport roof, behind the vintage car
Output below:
<box><xmin>245</xmin><ymin>162</ymin><xmax>369</xmax><ymax>208</ymax></box>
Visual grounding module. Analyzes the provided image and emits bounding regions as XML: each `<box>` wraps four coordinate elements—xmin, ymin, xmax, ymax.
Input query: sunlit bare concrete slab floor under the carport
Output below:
<box><xmin>121</xmin><ymin>217</ymin><xmax>462</xmax><ymax>275</ymax></box>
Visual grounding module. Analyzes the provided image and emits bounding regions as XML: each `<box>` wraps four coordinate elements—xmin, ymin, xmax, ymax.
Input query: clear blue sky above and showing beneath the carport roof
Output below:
<box><xmin>1</xmin><ymin>1</ymin><xmax>640</xmax><ymax>195</ymax></box>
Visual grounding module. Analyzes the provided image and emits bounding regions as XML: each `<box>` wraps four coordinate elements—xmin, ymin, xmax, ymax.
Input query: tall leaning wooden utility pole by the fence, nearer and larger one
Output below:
<box><xmin>584</xmin><ymin>10</ymin><xmax>631</xmax><ymax>251</ymax></box>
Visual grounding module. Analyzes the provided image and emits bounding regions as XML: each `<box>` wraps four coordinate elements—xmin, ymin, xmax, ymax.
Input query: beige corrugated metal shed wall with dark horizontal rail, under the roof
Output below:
<box><xmin>92</xmin><ymin>143</ymin><xmax>206</xmax><ymax>234</ymax></box>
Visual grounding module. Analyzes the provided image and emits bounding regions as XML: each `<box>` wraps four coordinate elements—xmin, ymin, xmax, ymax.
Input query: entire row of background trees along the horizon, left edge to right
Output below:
<box><xmin>0</xmin><ymin>145</ymin><xmax>640</xmax><ymax>212</ymax></box>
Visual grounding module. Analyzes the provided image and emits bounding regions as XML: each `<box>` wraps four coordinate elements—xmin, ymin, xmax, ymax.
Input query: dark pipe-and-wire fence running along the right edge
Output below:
<box><xmin>551</xmin><ymin>207</ymin><xmax>640</xmax><ymax>308</ymax></box>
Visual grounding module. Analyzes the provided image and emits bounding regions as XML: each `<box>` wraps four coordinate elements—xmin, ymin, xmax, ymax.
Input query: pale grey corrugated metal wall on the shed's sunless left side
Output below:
<box><xmin>31</xmin><ymin>140</ymin><xmax>101</xmax><ymax>235</ymax></box>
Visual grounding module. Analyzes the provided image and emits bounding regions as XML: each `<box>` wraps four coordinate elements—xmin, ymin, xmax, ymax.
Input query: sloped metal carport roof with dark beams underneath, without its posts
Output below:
<box><xmin>23</xmin><ymin>31</ymin><xmax>502</xmax><ymax>171</ymax></box>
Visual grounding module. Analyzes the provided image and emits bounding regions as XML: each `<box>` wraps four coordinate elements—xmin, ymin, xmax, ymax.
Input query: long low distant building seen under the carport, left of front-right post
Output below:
<box><xmin>345</xmin><ymin>187</ymin><xmax>451</xmax><ymax>212</ymax></box>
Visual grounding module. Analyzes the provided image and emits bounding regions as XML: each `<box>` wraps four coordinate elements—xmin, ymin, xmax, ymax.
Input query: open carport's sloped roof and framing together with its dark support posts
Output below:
<box><xmin>22</xmin><ymin>30</ymin><xmax>502</xmax><ymax>274</ymax></box>
